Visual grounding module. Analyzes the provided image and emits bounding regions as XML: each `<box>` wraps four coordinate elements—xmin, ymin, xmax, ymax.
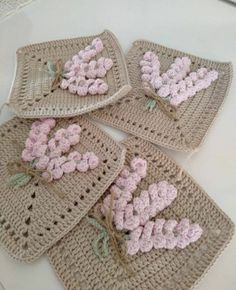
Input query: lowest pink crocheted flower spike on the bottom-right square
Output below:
<box><xmin>127</xmin><ymin>219</ymin><xmax>202</xmax><ymax>255</ymax></box>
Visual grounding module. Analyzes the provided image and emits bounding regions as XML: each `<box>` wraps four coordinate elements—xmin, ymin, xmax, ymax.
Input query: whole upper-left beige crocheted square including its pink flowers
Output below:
<box><xmin>9</xmin><ymin>31</ymin><xmax>131</xmax><ymax>118</ymax></box>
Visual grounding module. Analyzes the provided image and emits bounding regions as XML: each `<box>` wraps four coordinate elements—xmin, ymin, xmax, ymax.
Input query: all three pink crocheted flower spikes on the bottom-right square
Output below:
<box><xmin>101</xmin><ymin>158</ymin><xmax>202</xmax><ymax>255</ymax></box>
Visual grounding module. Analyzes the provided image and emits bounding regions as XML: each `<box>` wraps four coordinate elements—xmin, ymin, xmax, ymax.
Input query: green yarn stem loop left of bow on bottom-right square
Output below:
<box><xmin>87</xmin><ymin>217</ymin><xmax>109</xmax><ymax>259</ymax></box>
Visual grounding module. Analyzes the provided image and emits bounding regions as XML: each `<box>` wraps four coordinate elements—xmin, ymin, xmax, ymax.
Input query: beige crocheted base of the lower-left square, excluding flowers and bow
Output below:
<box><xmin>0</xmin><ymin>116</ymin><xmax>125</xmax><ymax>262</ymax></box>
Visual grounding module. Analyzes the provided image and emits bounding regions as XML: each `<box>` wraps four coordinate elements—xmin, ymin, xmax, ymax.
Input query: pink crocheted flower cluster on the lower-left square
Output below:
<box><xmin>22</xmin><ymin>119</ymin><xmax>99</xmax><ymax>180</ymax></box>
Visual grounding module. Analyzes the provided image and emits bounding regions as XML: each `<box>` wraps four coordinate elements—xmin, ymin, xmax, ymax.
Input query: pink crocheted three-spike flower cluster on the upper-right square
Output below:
<box><xmin>140</xmin><ymin>51</ymin><xmax>218</xmax><ymax>106</ymax></box>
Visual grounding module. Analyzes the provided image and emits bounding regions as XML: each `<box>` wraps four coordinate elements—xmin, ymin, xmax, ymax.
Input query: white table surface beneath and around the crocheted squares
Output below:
<box><xmin>0</xmin><ymin>0</ymin><xmax>236</xmax><ymax>290</ymax></box>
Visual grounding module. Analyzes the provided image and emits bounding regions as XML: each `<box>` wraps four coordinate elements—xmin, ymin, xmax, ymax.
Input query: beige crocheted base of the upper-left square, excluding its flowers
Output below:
<box><xmin>9</xmin><ymin>31</ymin><xmax>131</xmax><ymax>118</ymax></box>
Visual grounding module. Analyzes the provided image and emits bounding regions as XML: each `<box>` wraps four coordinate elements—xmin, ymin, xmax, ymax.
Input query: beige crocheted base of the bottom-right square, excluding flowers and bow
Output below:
<box><xmin>48</xmin><ymin>137</ymin><xmax>234</xmax><ymax>290</ymax></box>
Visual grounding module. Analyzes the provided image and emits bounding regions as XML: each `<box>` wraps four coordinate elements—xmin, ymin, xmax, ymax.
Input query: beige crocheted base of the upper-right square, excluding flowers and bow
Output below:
<box><xmin>91</xmin><ymin>41</ymin><xmax>232</xmax><ymax>152</ymax></box>
